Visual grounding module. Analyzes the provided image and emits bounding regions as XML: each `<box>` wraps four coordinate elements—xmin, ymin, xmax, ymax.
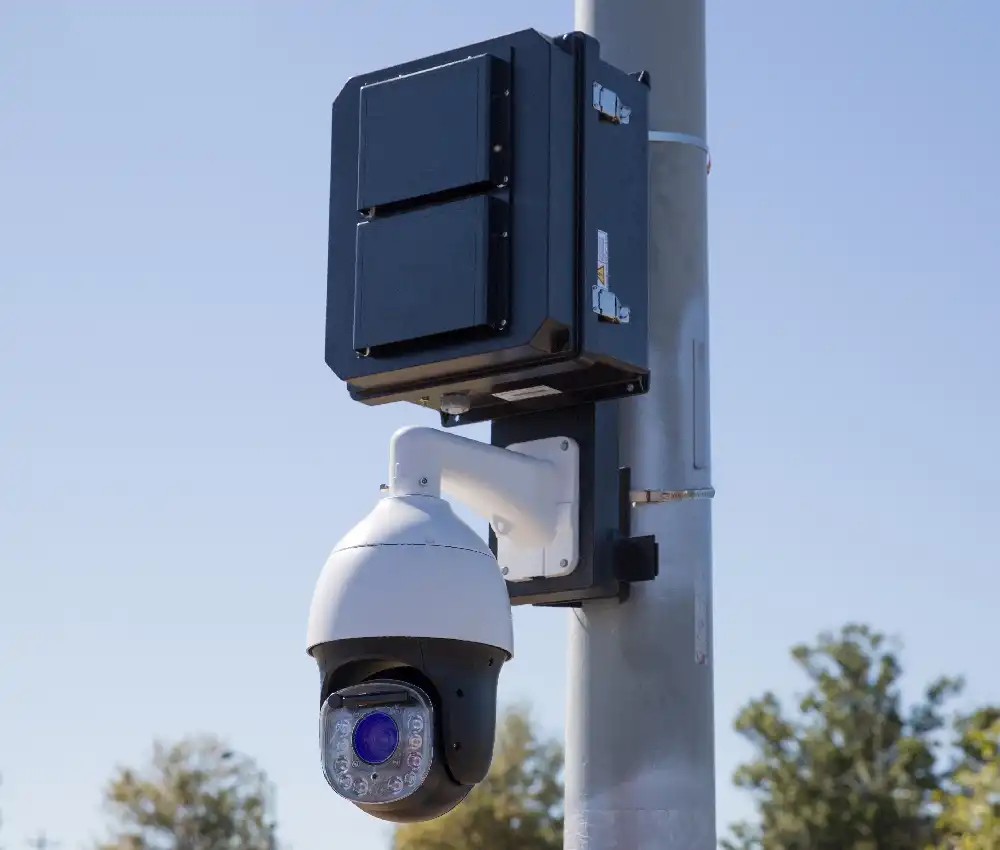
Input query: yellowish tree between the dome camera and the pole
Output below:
<box><xmin>392</xmin><ymin>706</ymin><xmax>563</xmax><ymax>850</ymax></box>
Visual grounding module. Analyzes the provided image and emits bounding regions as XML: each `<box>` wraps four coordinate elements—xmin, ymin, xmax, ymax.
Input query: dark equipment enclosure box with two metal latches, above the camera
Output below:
<box><xmin>326</xmin><ymin>30</ymin><xmax>648</xmax><ymax>425</ymax></box>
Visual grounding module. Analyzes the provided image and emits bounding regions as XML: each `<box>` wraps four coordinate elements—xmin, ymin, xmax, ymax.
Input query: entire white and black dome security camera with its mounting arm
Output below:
<box><xmin>307</xmin><ymin>428</ymin><xmax>579</xmax><ymax>823</ymax></box>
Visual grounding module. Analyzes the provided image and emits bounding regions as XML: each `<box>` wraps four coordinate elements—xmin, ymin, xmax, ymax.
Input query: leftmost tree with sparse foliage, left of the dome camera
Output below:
<box><xmin>101</xmin><ymin>736</ymin><xmax>276</xmax><ymax>850</ymax></box>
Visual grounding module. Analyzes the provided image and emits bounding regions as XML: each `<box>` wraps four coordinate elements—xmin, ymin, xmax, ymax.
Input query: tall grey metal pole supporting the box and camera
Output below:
<box><xmin>564</xmin><ymin>0</ymin><xmax>716</xmax><ymax>850</ymax></box>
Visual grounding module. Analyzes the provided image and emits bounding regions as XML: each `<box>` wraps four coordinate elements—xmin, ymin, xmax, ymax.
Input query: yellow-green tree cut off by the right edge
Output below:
<box><xmin>935</xmin><ymin>708</ymin><xmax>1000</xmax><ymax>850</ymax></box>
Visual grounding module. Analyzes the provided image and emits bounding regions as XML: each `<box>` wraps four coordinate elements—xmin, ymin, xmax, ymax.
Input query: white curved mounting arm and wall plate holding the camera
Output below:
<box><xmin>389</xmin><ymin>427</ymin><xmax>580</xmax><ymax>581</ymax></box>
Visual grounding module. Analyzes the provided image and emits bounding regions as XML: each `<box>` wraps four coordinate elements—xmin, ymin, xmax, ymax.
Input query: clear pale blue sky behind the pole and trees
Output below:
<box><xmin>0</xmin><ymin>0</ymin><xmax>1000</xmax><ymax>850</ymax></box>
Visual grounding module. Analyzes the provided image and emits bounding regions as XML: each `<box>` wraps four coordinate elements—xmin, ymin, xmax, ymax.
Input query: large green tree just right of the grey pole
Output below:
<box><xmin>722</xmin><ymin>625</ymin><xmax>964</xmax><ymax>850</ymax></box>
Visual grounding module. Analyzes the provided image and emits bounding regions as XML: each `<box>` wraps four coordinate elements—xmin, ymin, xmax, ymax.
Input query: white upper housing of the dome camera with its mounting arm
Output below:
<box><xmin>307</xmin><ymin>428</ymin><xmax>580</xmax><ymax>655</ymax></box>
